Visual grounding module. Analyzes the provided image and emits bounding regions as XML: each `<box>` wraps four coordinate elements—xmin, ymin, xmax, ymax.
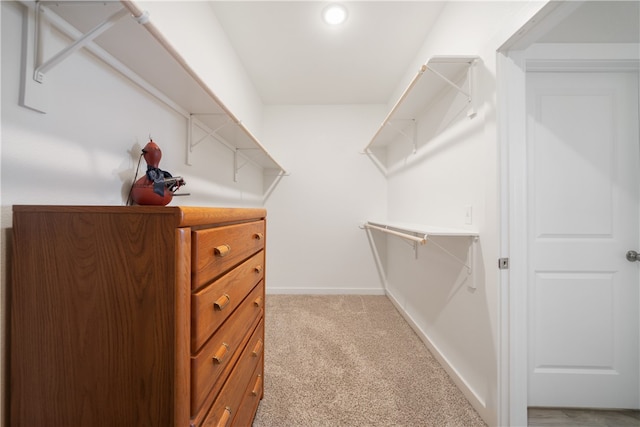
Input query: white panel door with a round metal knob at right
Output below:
<box><xmin>527</xmin><ymin>72</ymin><xmax>640</xmax><ymax>408</ymax></box>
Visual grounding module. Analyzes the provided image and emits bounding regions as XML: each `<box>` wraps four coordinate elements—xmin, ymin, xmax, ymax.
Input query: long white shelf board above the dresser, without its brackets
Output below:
<box><xmin>24</xmin><ymin>1</ymin><xmax>286</xmax><ymax>174</ymax></box>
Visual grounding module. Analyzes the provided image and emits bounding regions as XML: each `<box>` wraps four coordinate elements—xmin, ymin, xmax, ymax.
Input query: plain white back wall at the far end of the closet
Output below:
<box><xmin>264</xmin><ymin>105</ymin><xmax>386</xmax><ymax>294</ymax></box>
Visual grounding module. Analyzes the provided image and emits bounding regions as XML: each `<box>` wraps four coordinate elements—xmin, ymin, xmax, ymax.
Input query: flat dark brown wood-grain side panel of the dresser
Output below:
<box><xmin>11</xmin><ymin>213</ymin><xmax>178</xmax><ymax>426</ymax></box>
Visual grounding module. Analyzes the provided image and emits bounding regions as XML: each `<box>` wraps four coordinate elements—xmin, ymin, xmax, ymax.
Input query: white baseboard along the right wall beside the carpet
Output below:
<box><xmin>386</xmin><ymin>290</ymin><xmax>493</xmax><ymax>422</ymax></box>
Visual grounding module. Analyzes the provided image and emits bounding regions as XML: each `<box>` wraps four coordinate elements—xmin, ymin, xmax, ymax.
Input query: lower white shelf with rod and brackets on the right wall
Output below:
<box><xmin>362</xmin><ymin>221</ymin><xmax>480</xmax><ymax>289</ymax></box>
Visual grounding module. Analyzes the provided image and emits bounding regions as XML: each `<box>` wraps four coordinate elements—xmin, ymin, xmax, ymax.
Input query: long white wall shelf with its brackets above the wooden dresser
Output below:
<box><xmin>22</xmin><ymin>1</ymin><xmax>286</xmax><ymax>184</ymax></box>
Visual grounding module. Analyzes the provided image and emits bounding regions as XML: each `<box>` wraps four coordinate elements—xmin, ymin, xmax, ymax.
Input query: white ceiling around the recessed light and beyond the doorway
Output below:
<box><xmin>211</xmin><ymin>0</ymin><xmax>640</xmax><ymax>104</ymax></box>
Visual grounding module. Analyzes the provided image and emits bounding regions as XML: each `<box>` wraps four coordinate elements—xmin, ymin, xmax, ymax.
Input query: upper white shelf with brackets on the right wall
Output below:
<box><xmin>364</xmin><ymin>56</ymin><xmax>478</xmax><ymax>152</ymax></box>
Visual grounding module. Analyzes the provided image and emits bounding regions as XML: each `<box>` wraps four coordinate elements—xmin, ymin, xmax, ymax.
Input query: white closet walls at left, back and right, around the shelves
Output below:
<box><xmin>0</xmin><ymin>2</ymin><xmax>552</xmax><ymax>424</ymax></box>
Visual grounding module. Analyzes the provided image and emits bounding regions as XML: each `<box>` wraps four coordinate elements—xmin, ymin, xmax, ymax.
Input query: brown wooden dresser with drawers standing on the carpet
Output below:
<box><xmin>8</xmin><ymin>206</ymin><xmax>266</xmax><ymax>427</ymax></box>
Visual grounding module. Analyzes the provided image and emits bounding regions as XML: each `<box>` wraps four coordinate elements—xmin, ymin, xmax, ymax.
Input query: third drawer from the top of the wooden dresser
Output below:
<box><xmin>191</xmin><ymin>284</ymin><xmax>264</xmax><ymax>414</ymax></box>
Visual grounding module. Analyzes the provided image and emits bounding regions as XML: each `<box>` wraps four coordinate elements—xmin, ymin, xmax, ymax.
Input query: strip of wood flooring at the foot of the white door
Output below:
<box><xmin>528</xmin><ymin>408</ymin><xmax>640</xmax><ymax>427</ymax></box>
